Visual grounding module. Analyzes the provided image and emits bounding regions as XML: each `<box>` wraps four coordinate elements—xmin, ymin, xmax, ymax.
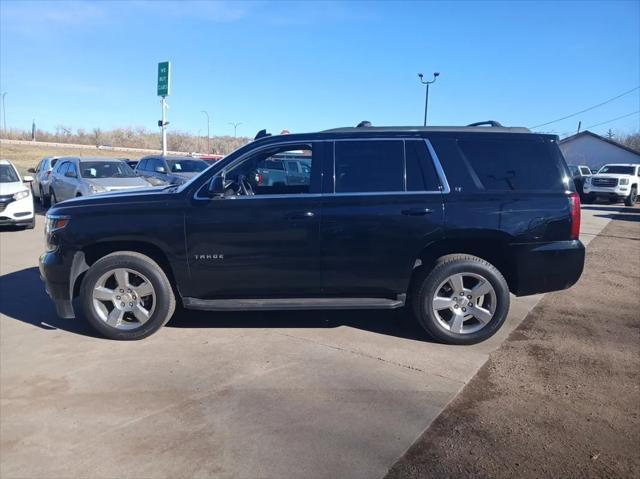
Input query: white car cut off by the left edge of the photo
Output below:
<box><xmin>0</xmin><ymin>160</ymin><xmax>36</xmax><ymax>229</ymax></box>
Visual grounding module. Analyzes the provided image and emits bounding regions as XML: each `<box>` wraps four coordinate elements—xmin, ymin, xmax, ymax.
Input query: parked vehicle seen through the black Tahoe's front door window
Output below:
<box><xmin>252</xmin><ymin>150</ymin><xmax>311</xmax><ymax>192</ymax></box>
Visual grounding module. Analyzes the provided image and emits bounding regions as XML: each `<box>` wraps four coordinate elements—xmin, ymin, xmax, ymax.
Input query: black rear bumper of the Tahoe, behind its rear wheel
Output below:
<box><xmin>512</xmin><ymin>240</ymin><xmax>585</xmax><ymax>296</ymax></box>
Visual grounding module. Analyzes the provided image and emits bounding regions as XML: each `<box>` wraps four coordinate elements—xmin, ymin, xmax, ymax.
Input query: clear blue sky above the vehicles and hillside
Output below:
<box><xmin>0</xmin><ymin>0</ymin><xmax>640</xmax><ymax>136</ymax></box>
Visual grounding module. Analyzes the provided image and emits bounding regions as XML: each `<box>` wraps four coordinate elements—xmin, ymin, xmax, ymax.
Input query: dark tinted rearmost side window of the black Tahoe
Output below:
<box><xmin>458</xmin><ymin>138</ymin><xmax>564</xmax><ymax>191</ymax></box>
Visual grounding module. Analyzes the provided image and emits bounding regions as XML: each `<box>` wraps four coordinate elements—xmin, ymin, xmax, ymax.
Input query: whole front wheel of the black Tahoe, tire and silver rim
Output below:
<box><xmin>80</xmin><ymin>251</ymin><xmax>176</xmax><ymax>340</ymax></box>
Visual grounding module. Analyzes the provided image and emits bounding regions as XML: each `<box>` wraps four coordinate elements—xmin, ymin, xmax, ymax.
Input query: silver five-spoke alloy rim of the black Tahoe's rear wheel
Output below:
<box><xmin>431</xmin><ymin>273</ymin><xmax>496</xmax><ymax>334</ymax></box>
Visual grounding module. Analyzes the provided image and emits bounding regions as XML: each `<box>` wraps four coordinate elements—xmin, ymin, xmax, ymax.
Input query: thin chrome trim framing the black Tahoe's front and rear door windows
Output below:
<box><xmin>193</xmin><ymin>137</ymin><xmax>451</xmax><ymax>201</ymax></box>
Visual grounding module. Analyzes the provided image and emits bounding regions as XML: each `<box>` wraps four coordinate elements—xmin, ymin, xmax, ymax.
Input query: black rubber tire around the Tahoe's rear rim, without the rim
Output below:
<box><xmin>411</xmin><ymin>254</ymin><xmax>510</xmax><ymax>345</ymax></box>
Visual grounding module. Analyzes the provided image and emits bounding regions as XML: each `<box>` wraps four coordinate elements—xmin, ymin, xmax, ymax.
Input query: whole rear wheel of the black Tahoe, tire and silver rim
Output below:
<box><xmin>412</xmin><ymin>254</ymin><xmax>509</xmax><ymax>344</ymax></box>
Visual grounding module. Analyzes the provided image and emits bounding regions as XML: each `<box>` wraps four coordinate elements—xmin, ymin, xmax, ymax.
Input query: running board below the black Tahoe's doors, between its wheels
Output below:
<box><xmin>182</xmin><ymin>294</ymin><xmax>405</xmax><ymax>311</ymax></box>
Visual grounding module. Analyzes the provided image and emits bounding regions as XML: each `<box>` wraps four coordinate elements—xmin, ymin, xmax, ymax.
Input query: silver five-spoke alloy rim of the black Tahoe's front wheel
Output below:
<box><xmin>92</xmin><ymin>268</ymin><xmax>156</xmax><ymax>330</ymax></box>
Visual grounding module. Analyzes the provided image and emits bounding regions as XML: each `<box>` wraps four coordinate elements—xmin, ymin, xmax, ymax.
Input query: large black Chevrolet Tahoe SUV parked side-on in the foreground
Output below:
<box><xmin>40</xmin><ymin>124</ymin><xmax>585</xmax><ymax>344</ymax></box>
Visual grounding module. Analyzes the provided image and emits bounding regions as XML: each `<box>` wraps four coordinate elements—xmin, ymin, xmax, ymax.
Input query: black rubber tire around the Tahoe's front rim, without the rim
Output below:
<box><xmin>80</xmin><ymin>251</ymin><xmax>176</xmax><ymax>340</ymax></box>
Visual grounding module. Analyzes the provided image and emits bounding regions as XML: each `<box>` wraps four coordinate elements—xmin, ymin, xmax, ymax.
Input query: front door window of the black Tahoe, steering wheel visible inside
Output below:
<box><xmin>225</xmin><ymin>144</ymin><xmax>320</xmax><ymax>196</ymax></box>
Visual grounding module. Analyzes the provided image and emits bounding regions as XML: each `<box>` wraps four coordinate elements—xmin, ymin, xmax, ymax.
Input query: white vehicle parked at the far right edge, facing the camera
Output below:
<box><xmin>584</xmin><ymin>164</ymin><xmax>640</xmax><ymax>206</ymax></box>
